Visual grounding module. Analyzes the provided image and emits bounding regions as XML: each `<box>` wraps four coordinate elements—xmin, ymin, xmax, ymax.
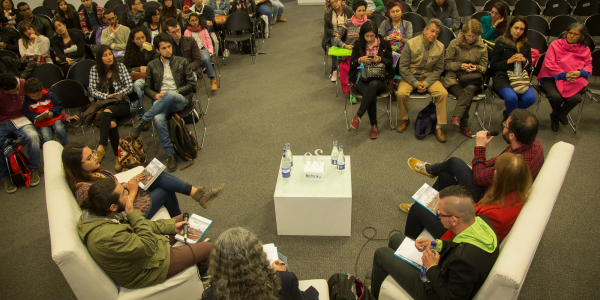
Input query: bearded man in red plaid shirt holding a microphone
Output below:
<box><xmin>400</xmin><ymin>109</ymin><xmax>544</xmax><ymax>212</ymax></box>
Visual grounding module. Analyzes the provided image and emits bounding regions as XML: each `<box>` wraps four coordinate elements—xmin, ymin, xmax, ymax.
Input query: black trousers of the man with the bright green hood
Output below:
<box><xmin>371</xmin><ymin>234</ymin><xmax>429</xmax><ymax>300</ymax></box>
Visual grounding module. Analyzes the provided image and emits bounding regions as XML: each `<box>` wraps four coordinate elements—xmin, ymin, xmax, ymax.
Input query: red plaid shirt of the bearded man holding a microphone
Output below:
<box><xmin>473</xmin><ymin>139</ymin><xmax>544</xmax><ymax>187</ymax></box>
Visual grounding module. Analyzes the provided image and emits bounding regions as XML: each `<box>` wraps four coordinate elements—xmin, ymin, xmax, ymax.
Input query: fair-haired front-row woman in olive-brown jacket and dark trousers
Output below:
<box><xmin>443</xmin><ymin>19</ymin><xmax>488</xmax><ymax>137</ymax></box>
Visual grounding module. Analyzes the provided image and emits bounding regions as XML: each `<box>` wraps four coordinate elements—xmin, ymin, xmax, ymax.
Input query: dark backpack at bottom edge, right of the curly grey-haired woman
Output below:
<box><xmin>327</xmin><ymin>273</ymin><xmax>370</xmax><ymax>300</ymax></box>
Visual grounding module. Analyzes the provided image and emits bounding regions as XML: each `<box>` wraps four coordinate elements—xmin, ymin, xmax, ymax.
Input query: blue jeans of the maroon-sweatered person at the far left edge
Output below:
<box><xmin>0</xmin><ymin>121</ymin><xmax>40</xmax><ymax>179</ymax></box>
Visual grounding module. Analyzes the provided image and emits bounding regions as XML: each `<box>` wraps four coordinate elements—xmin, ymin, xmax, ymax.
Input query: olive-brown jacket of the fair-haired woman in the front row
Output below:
<box><xmin>442</xmin><ymin>32</ymin><xmax>488</xmax><ymax>88</ymax></box>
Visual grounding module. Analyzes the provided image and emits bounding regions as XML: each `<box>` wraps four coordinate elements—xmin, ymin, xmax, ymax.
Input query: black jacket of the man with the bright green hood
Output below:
<box><xmin>427</xmin><ymin>216</ymin><xmax>500</xmax><ymax>300</ymax></box>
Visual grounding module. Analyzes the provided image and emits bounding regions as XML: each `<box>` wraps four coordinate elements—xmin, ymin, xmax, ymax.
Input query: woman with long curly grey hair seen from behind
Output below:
<box><xmin>202</xmin><ymin>227</ymin><xmax>319</xmax><ymax>300</ymax></box>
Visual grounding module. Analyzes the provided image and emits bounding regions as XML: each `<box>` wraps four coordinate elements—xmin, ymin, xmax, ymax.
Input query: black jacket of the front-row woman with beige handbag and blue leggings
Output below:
<box><xmin>490</xmin><ymin>36</ymin><xmax>531</xmax><ymax>91</ymax></box>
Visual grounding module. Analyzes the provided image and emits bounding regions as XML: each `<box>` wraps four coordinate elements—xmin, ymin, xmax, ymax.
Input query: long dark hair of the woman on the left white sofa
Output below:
<box><xmin>61</xmin><ymin>143</ymin><xmax>101</xmax><ymax>194</ymax></box>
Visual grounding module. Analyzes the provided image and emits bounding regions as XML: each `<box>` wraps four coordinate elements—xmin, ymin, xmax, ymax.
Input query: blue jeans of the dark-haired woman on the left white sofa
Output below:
<box><xmin>146</xmin><ymin>172</ymin><xmax>191</xmax><ymax>219</ymax></box>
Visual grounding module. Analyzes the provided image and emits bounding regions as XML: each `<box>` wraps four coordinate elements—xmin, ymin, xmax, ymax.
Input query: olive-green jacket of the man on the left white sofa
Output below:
<box><xmin>77</xmin><ymin>210</ymin><xmax>175</xmax><ymax>288</ymax></box>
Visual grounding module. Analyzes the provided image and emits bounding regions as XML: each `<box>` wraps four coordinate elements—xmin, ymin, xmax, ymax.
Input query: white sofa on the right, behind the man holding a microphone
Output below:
<box><xmin>379</xmin><ymin>142</ymin><xmax>575</xmax><ymax>300</ymax></box>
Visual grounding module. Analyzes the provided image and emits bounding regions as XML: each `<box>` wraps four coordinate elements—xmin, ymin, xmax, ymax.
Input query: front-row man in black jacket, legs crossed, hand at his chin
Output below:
<box><xmin>131</xmin><ymin>33</ymin><xmax>196</xmax><ymax>172</ymax></box>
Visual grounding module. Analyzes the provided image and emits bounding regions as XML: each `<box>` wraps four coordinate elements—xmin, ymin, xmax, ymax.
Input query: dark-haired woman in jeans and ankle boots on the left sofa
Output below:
<box><xmin>62</xmin><ymin>143</ymin><xmax>224</xmax><ymax>219</ymax></box>
